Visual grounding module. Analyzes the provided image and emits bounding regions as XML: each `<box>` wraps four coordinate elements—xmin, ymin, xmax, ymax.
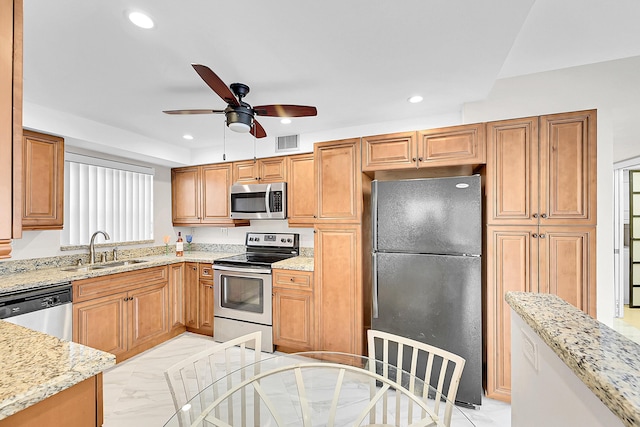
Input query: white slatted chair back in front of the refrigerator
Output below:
<box><xmin>367</xmin><ymin>329</ymin><xmax>465</xmax><ymax>427</ymax></box>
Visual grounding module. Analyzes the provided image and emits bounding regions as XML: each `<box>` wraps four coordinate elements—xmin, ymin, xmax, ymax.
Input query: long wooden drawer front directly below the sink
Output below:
<box><xmin>73</xmin><ymin>266</ymin><xmax>169</xmax><ymax>303</ymax></box>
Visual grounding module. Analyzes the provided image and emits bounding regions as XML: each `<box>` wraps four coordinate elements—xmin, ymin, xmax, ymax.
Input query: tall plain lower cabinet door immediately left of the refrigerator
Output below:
<box><xmin>314</xmin><ymin>224</ymin><xmax>364</xmax><ymax>354</ymax></box>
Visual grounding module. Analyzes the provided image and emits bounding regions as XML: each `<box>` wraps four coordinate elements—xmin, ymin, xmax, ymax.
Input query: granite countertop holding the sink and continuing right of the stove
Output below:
<box><xmin>0</xmin><ymin>252</ymin><xmax>313</xmax><ymax>296</ymax></box>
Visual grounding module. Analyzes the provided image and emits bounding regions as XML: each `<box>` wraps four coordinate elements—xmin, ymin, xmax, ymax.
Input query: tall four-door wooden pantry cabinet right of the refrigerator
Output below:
<box><xmin>485</xmin><ymin>110</ymin><xmax>596</xmax><ymax>401</ymax></box>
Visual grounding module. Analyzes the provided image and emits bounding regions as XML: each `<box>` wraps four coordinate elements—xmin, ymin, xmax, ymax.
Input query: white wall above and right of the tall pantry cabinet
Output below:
<box><xmin>463</xmin><ymin>57</ymin><xmax>640</xmax><ymax>325</ymax></box>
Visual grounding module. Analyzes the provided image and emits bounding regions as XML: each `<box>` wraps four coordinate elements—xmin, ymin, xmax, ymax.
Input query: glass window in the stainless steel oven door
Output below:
<box><xmin>220</xmin><ymin>275</ymin><xmax>262</xmax><ymax>313</ymax></box>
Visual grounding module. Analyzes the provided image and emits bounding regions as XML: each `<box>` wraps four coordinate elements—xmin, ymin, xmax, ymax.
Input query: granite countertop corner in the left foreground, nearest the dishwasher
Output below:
<box><xmin>0</xmin><ymin>320</ymin><xmax>116</xmax><ymax>420</ymax></box>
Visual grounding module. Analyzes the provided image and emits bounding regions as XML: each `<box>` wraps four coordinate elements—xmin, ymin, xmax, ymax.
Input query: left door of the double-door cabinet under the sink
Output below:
<box><xmin>73</xmin><ymin>292</ymin><xmax>128</xmax><ymax>356</ymax></box>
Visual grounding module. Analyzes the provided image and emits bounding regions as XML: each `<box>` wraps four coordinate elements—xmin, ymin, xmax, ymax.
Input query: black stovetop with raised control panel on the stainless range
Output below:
<box><xmin>213</xmin><ymin>236</ymin><xmax>300</xmax><ymax>268</ymax></box>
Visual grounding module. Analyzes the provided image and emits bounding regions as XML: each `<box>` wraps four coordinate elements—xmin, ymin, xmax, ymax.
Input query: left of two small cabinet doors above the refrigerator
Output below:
<box><xmin>362</xmin><ymin>132</ymin><xmax>418</xmax><ymax>171</ymax></box>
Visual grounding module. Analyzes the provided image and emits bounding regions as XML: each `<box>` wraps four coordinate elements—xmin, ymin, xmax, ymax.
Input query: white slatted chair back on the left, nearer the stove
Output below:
<box><xmin>164</xmin><ymin>332</ymin><xmax>262</xmax><ymax>426</ymax></box>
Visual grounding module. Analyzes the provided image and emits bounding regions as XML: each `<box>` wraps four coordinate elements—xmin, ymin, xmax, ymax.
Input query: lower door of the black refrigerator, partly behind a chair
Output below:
<box><xmin>372</xmin><ymin>253</ymin><xmax>482</xmax><ymax>405</ymax></box>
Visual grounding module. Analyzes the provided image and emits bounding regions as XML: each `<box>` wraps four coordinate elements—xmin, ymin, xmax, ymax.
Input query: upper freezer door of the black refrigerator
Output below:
<box><xmin>372</xmin><ymin>176</ymin><xmax>482</xmax><ymax>255</ymax></box>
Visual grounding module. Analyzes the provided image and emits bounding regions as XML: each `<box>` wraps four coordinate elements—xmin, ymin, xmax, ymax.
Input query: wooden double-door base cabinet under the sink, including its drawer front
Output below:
<box><xmin>73</xmin><ymin>267</ymin><xmax>178</xmax><ymax>362</ymax></box>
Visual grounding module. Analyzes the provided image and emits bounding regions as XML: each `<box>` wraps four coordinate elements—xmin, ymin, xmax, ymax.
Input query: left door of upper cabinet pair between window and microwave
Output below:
<box><xmin>171</xmin><ymin>166</ymin><xmax>201</xmax><ymax>225</ymax></box>
